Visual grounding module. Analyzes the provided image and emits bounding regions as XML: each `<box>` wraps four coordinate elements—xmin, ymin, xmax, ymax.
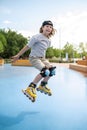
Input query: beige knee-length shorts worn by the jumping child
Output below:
<box><xmin>29</xmin><ymin>57</ymin><xmax>52</xmax><ymax>71</ymax></box>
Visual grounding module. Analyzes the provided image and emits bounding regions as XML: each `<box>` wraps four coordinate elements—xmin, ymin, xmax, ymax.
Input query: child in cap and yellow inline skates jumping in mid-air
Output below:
<box><xmin>12</xmin><ymin>20</ymin><xmax>56</xmax><ymax>102</ymax></box>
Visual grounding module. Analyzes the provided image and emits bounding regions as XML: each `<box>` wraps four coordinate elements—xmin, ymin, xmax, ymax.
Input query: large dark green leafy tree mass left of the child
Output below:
<box><xmin>0</xmin><ymin>29</ymin><xmax>28</xmax><ymax>58</ymax></box>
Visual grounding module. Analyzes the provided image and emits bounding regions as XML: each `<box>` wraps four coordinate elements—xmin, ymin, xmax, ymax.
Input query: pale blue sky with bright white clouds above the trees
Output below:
<box><xmin>0</xmin><ymin>0</ymin><xmax>87</xmax><ymax>48</ymax></box>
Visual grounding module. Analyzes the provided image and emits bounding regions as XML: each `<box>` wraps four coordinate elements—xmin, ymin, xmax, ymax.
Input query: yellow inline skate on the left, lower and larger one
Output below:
<box><xmin>22</xmin><ymin>83</ymin><xmax>37</xmax><ymax>102</ymax></box>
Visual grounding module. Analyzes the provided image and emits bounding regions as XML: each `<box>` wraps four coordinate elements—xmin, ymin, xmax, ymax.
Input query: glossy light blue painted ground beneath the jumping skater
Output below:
<box><xmin>0</xmin><ymin>64</ymin><xmax>87</xmax><ymax>130</ymax></box>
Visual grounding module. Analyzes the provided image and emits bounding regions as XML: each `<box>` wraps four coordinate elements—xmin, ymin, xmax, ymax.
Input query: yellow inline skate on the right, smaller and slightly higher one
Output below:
<box><xmin>37</xmin><ymin>81</ymin><xmax>52</xmax><ymax>96</ymax></box>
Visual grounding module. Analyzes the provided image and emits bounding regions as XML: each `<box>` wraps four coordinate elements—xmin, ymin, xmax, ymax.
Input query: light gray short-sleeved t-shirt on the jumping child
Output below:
<box><xmin>27</xmin><ymin>33</ymin><xmax>51</xmax><ymax>57</ymax></box>
